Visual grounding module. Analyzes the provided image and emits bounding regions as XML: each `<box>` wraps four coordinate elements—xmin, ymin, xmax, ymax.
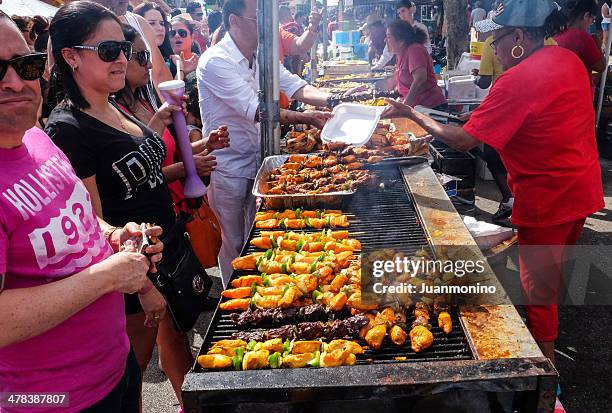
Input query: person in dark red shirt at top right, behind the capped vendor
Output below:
<box><xmin>555</xmin><ymin>0</ymin><xmax>606</xmax><ymax>98</ymax></box>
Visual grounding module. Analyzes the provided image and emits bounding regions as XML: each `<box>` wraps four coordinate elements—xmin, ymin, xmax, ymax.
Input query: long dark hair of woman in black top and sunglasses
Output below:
<box><xmin>49</xmin><ymin>0</ymin><xmax>121</xmax><ymax>109</ymax></box>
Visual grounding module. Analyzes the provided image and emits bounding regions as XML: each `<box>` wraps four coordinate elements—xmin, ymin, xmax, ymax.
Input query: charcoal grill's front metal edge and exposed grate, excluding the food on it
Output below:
<box><xmin>183</xmin><ymin>167</ymin><xmax>556</xmax><ymax>413</ymax></box>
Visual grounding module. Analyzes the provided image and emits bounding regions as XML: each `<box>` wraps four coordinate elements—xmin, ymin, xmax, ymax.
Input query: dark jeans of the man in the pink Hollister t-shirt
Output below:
<box><xmin>81</xmin><ymin>349</ymin><xmax>142</xmax><ymax>413</ymax></box>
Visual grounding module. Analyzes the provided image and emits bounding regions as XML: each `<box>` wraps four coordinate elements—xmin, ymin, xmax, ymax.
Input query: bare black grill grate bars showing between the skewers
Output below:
<box><xmin>195</xmin><ymin>168</ymin><xmax>473</xmax><ymax>372</ymax></box>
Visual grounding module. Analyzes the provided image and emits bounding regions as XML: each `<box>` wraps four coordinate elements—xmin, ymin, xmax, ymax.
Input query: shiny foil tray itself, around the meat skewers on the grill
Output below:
<box><xmin>252</xmin><ymin>154</ymin><xmax>356</xmax><ymax>209</ymax></box>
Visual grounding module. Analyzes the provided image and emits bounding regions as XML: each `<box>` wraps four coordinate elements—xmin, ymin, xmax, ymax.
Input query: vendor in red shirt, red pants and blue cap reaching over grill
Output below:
<box><xmin>385</xmin><ymin>0</ymin><xmax>604</xmax><ymax>361</ymax></box>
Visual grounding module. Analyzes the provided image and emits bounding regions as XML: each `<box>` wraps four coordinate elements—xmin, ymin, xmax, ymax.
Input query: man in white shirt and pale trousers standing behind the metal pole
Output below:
<box><xmin>197</xmin><ymin>0</ymin><xmax>330</xmax><ymax>286</ymax></box>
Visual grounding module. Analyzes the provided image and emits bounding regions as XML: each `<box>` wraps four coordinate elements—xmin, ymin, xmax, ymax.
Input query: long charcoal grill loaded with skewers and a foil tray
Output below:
<box><xmin>183</xmin><ymin>1</ymin><xmax>558</xmax><ymax>413</ymax></box>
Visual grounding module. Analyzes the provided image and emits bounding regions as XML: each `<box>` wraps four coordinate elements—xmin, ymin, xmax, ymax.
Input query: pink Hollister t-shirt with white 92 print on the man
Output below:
<box><xmin>0</xmin><ymin>128</ymin><xmax>129</xmax><ymax>413</ymax></box>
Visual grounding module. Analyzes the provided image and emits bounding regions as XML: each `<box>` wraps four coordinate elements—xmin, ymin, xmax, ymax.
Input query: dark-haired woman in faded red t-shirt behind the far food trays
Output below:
<box><xmin>378</xmin><ymin>20</ymin><xmax>446</xmax><ymax>109</ymax></box>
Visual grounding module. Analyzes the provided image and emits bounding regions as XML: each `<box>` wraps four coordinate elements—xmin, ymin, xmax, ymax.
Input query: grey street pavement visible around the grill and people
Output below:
<box><xmin>143</xmin><ymin>160</ymin><xmax>612</xmax><ymax>413</ymax></box>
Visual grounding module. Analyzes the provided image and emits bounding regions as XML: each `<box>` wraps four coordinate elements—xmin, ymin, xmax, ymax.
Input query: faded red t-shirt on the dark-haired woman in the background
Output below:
<box><xmin>395</xmin><ymin>43</ymin><xmax>446</xmax><ymax>108</ymax></box>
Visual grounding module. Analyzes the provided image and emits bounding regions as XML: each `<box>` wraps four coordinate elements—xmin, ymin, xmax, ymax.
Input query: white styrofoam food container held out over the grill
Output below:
<box><xmin>321</xmin><ymin>103</ymin><xmax>384</xmax><ymax>146</ymax></box>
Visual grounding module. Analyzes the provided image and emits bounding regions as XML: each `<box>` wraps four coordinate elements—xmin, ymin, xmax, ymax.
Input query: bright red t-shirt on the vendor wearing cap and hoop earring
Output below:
<box><xmin>463</xmin><ymin>46</ymin><xmax>604</xmax><ymax>227</ymax></box>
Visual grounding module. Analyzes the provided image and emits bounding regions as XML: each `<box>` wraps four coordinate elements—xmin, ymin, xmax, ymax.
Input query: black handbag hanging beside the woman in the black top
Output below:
<box><xmin>149</xmin><ymin>213</ymin><xmax>212</xmax><ymax>332</ymax></box>
